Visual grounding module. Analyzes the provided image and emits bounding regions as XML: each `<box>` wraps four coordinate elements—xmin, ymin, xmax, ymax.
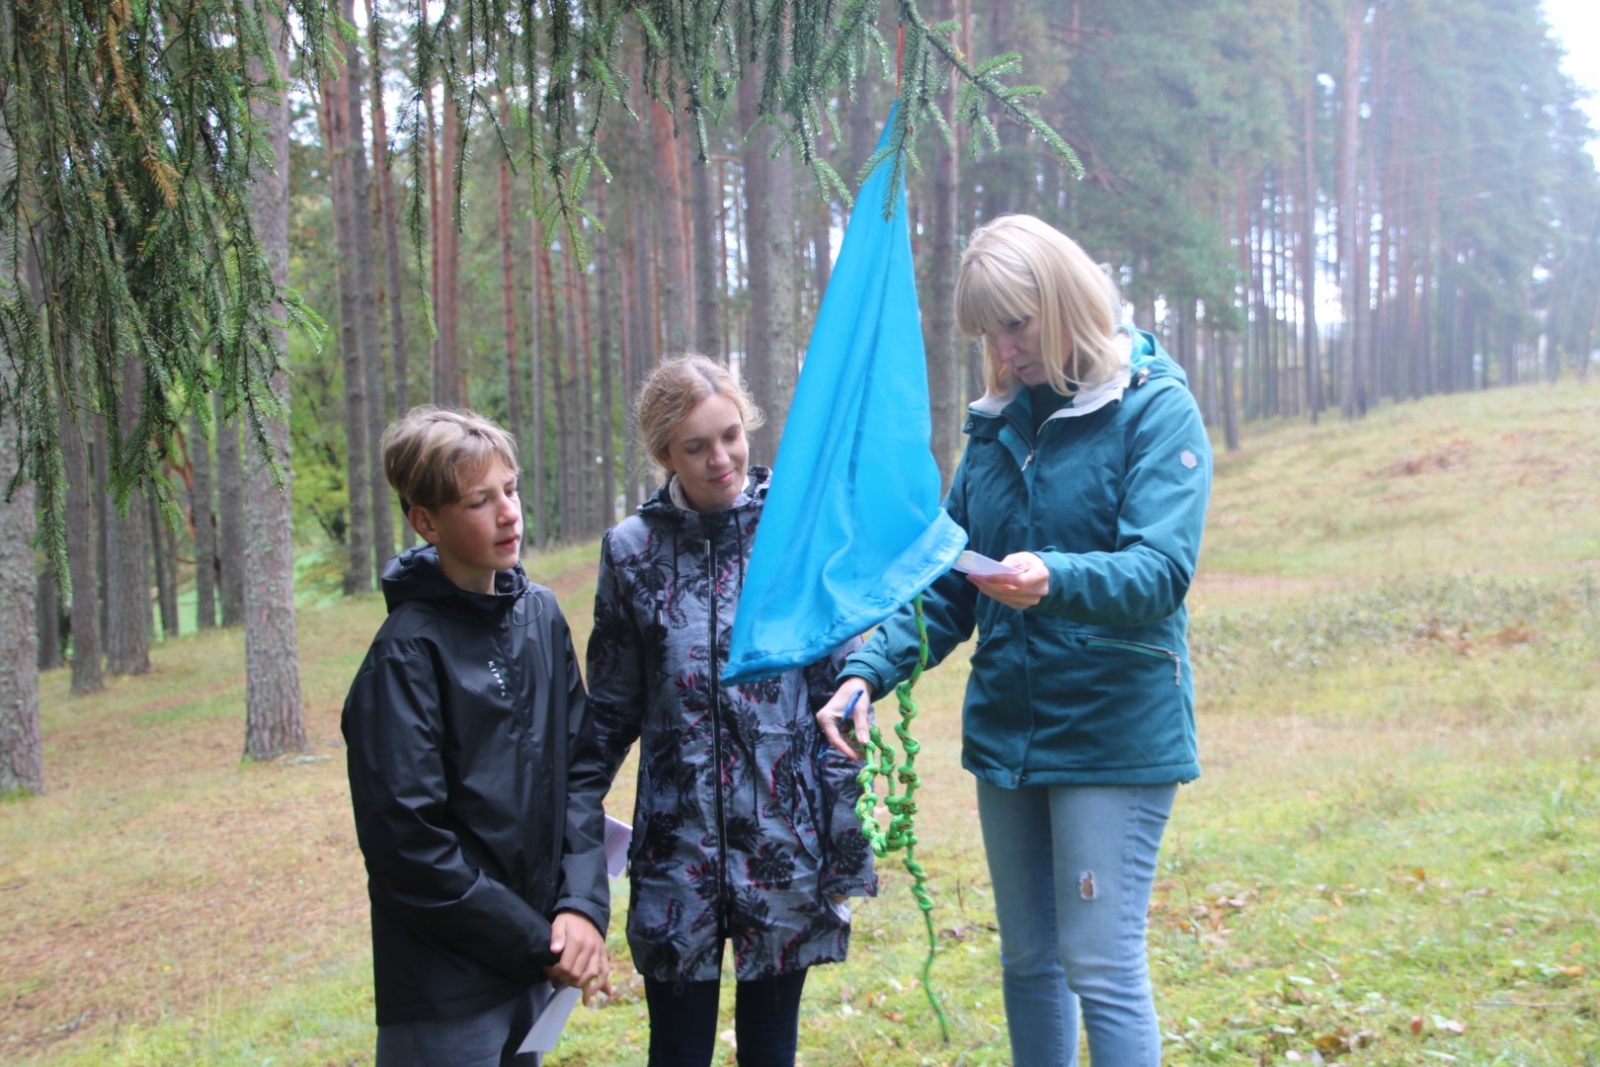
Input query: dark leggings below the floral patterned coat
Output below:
<box><xmin>645</xmin><ymin>969</ymin><xmax>805</xmax><ymax>1067</ymax></box>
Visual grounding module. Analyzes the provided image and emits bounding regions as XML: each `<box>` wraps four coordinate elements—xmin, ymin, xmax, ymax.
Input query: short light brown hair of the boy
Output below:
<box><xmin>382</xmin><ymin>403</ymin><xmax>520</xmax><ymax>512</ymax></box>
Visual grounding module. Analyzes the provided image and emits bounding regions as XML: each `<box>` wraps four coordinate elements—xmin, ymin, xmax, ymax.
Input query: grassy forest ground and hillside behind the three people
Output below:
<box><xmin>0</xmin><ymin>386</ymin><xmax>1600</xmax><ymax>1067</ymax></box>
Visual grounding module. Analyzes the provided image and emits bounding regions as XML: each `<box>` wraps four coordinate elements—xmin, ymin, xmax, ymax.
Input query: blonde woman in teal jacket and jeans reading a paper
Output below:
<box><xmin>818</xmin><ymin>214</ymin><xmax>1211</xmax><ymax>1067</ymax></box>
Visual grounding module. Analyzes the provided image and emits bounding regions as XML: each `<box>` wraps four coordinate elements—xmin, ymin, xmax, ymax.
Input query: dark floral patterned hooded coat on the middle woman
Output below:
<box><xmin>589</xmin><ymin>467</ymin><xmax>877</xmax><ymax>982</ymax></box>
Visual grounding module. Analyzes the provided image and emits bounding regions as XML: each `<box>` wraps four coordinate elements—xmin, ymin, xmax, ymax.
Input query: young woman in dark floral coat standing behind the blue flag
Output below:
<box><xmin>589</xmin><ymin>355</ymin><xmax>875</xmax><ymax>1067</ymax></box>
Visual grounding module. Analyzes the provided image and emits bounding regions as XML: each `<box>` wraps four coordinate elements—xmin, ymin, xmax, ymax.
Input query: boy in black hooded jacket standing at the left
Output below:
<box><xmin>342</xmin><ymin>406</ymin><xmax>610</xmax><ymax>1067</ymax></box>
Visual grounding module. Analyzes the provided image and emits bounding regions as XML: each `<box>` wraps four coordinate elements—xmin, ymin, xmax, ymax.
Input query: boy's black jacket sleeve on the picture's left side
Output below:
<box><xmin>344</xmin><ymin>643</ymin><xmax>560</xmax><ymax>984</ymax></box>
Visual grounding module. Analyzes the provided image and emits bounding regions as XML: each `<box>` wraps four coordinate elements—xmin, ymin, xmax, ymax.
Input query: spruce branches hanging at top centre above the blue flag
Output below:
<box><xmin>409</xmin><ymin>0</ymin><xmax>1082</xmax><ymax>258</ymax></box>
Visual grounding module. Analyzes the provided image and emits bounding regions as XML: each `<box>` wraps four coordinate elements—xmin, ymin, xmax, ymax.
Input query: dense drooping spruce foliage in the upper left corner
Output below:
<box><xmin>0</xmin><ymin>0</ymin><xmax>330</xmax><ymax>577</ymax></box>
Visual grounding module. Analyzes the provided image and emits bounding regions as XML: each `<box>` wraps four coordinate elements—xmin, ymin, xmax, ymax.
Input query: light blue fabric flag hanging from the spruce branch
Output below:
<box><xmin>722</xmin><ymin>112</ymin><xmax>966</xmax><ymax>685</ymax></box>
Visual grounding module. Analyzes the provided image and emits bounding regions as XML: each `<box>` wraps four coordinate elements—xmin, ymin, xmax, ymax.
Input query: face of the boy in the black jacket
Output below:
<box><xmin>406</xmin><ymin>456</ymin><xmax>522</xmax><ymax>593</ymax></box>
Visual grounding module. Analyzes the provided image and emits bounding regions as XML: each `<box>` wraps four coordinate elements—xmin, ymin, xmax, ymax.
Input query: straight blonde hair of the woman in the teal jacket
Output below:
<box><xmin>955</xmin><ymin>214</ymin><xmax>1123</xmax><ymax>395</ymax></box>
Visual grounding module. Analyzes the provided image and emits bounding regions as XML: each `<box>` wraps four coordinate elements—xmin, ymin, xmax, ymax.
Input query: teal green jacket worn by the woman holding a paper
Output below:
<box><xmin>840</xmin><ymin>333</ymin><xmax>1211</xmax><ymax>787</ymax></box>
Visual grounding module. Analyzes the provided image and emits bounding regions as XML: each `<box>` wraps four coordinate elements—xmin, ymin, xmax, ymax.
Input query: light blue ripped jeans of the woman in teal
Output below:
<box><xmin>978</xmin><ymin>781</ymin><xmax>1178</xmax><ymax>1067</ymax></box>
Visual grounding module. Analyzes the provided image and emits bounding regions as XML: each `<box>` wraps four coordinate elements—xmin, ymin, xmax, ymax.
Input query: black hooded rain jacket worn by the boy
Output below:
<box><xmin>342</xmin><ymin>545</ymin><xmax>610</xmax><ymax>1025</ymax></box>
